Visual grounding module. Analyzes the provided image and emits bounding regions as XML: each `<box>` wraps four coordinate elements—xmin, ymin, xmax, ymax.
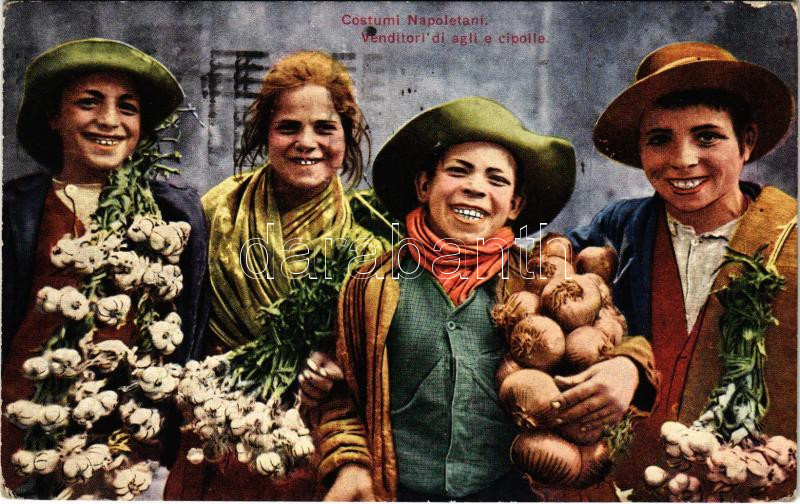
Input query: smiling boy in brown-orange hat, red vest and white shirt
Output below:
<box><xmin>569</xmin><ymin>42</ymin><xmax>797</xmax><ymax>498</ymax></box>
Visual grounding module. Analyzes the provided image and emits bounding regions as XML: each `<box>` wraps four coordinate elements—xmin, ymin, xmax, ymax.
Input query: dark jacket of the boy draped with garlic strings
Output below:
<box><xmin>2</xmin><ymin>174</ymin><xmax>209</xmax><ymax>362</ymax></box>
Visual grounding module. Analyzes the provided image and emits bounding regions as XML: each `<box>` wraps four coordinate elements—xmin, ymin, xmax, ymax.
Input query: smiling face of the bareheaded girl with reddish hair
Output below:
<box><xmin>268</xmin><ymin>84</ymin><xmax>345</xmax><ymax>208</ymax></box>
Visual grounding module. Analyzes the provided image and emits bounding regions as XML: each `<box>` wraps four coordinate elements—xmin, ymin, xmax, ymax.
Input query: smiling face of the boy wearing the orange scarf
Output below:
<box><xmin>416</xmin><ymin>142</ymin><xmax>523</xmax><ymax>245</ymax></box>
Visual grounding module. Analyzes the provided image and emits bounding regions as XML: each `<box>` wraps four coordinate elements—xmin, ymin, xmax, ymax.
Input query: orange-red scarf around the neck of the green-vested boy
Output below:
<box><xmin>406</xmin><ymin>206</ymin><xmax>514</xmax><ymax>306</ymax></box>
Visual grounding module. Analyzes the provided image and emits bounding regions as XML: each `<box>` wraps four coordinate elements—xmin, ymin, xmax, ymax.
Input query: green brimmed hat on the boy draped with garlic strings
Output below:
<box><xmin>17</xmin><ymin>38</ymin><xmax>183</xmax><ymax>170</ymax></box>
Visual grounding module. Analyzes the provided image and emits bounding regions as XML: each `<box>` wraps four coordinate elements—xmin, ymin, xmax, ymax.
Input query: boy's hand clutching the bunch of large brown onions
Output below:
<box><xmin>555</xmin><ymin>357</ymin><xmax>639</xmax><ymax>429</ymax></box>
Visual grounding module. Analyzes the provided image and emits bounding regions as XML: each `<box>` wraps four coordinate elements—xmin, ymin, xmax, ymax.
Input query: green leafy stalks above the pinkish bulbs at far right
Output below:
<box><xmin>695</xmin><ymin>244</ymin><xmax>786</xmax><ymax>444</ymax></box>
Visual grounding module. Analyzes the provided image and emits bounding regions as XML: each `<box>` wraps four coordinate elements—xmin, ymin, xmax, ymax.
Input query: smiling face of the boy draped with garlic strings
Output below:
<box><xmin>49</xmin><ymin>72</ymin><xmax>141</xmax><ymax>183</ymax></box>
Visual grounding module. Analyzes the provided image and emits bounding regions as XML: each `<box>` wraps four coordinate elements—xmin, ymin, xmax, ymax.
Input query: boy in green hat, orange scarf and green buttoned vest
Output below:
<box><xmin>319</xmin><ymin>97</ymin><xmax>660</xmax><ymax>501</ymax></box>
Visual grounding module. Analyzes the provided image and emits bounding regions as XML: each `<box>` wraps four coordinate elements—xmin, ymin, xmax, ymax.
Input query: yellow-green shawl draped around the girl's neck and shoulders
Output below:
<box><xmin>203</xmin><ymin>167</ymin><xmax>387</xmax><ymax>347</ymax></box>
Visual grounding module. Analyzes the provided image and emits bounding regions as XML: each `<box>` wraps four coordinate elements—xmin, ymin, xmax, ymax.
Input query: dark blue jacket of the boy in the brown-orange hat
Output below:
<box><xmin>566</xmin><ymin>182</ymin><xmax>761</xmax><ymax>339</ymax></box>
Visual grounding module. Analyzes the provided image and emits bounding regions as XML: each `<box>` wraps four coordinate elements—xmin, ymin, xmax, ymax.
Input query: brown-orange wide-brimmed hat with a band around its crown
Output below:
<box><xmin>594</xmin><ymin>42</ymin><xmax>794</xmax><ymax>168</ymax></box>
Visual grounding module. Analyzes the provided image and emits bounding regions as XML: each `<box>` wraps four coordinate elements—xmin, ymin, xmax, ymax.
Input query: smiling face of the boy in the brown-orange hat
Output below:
<box><xmin>639</xmin><ymin>105</ymin><xmax>756</xmax><ymax>233</ymax></box>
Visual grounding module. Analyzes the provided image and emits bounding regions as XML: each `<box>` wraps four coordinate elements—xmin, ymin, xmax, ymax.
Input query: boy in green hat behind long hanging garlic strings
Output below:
<box><xmin>2</xmin><ymin>38</ymin><xmax>207</xmax><ymax>488</ymax></box>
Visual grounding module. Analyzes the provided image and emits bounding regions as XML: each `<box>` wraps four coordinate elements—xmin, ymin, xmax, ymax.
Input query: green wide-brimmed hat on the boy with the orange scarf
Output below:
<box><xmin>372</xmin><ymin>96</ymin><xmax>575</xmax><ymax>233</ymax></box>
